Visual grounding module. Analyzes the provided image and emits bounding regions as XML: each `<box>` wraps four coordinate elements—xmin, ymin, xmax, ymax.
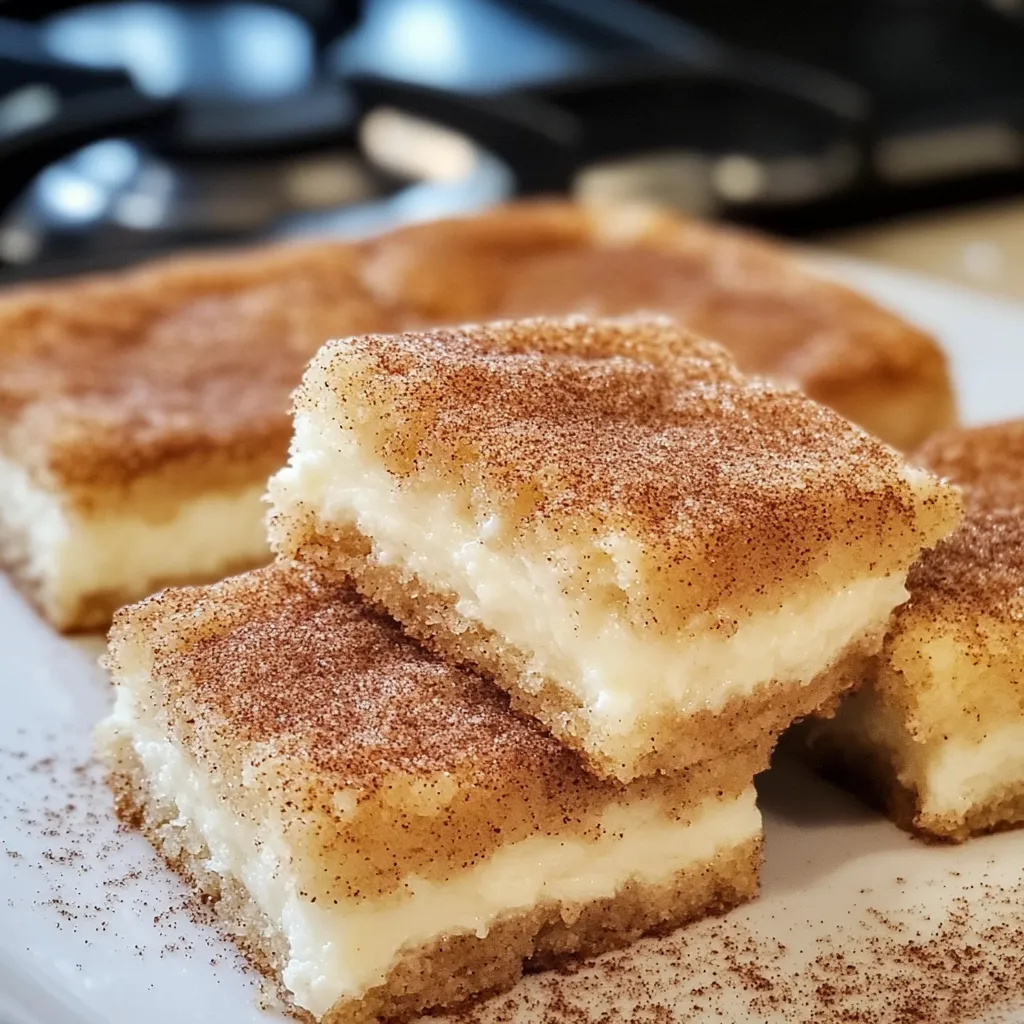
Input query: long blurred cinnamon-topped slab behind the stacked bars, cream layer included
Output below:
<box><xmin>0</xmin><ymin>203</ymin><xmax>953</xmax><ymax>630</ymax></box>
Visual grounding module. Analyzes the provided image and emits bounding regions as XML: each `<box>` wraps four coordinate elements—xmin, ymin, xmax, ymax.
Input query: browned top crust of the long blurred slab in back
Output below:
<box><xmin>0</xmin><ymin>203</ymin><xmax>951</xmax><ymax>501</ymax></box>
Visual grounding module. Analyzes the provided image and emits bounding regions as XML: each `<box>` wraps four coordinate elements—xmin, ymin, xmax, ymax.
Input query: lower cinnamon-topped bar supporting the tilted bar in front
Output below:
<box><xmin>99</xmin><ymin>563</ymin><xmax>768</xmax><ymax>1024</ymax></box>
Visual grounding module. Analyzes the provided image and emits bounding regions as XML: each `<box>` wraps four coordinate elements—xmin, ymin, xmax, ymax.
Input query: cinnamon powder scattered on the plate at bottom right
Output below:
<box><xmin>454</xmin><ymin>871</ymin><xmax>1024</xmax><ymax>1024</ymax></box>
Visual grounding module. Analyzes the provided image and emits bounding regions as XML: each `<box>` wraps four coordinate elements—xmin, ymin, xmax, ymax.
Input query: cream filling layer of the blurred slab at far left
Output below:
<box><xmin>0</xmin><ymin>459</ymin><xmax>267</xmax><ymax>610</ymax></box>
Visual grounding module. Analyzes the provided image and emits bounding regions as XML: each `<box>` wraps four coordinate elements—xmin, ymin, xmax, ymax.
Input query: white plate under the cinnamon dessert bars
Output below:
<box><xmin>0</xmin><ymin>261</ymin><xmax>1024</xmax><ymax>1024</ymax></box>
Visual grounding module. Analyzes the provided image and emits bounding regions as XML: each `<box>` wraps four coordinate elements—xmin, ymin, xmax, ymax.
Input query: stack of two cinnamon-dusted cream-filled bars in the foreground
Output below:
<box><xmin>101</xmin><ymin>317</ymin><xmax>959</xmax><ymax>1024</ymax></box>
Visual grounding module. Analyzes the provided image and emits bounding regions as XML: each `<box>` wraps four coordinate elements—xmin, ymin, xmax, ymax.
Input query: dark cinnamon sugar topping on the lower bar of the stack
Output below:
<box><xmin>136</xmin><ymin>563</ymin><xmax>595</xmax><ymax>793</ymax></box>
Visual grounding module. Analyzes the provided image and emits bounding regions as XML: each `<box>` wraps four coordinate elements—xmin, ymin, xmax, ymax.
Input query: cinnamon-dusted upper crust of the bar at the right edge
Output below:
<box><xmin>878</xmin><ymin>421</ymin><xmax>1024</xmax><ymax>741</ymax></box>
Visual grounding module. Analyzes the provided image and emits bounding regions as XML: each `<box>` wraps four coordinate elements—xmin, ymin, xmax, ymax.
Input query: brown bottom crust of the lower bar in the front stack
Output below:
<box><xmin>108</xmin><ymin>729</ymin><xmax>761</xmax><ymax>1024</ymax></box>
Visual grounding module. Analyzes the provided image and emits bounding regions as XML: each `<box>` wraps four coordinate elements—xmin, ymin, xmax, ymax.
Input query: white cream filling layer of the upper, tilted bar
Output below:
<box><xmin>270</xmin><ymin>413</ymin><xmax>907</xmax><ymax>736</ymax></box>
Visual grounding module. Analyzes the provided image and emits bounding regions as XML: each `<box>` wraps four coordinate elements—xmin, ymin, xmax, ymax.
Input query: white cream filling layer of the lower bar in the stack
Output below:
<box><xmin>105</xmin><ymin>683</ymin><xmax>761</xmax><ymax>1016</ymax></box>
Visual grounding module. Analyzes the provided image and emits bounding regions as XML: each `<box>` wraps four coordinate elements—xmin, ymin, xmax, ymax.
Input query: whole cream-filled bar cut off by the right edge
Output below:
<box><xmin>804</xmin><ymin>421</ymin><xmax>1024</xmax><ymax>840</ymax></box>
